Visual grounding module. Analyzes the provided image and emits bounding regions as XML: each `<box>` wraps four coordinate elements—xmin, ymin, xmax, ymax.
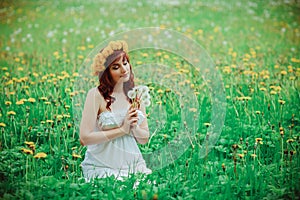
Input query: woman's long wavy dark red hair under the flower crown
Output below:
<box><xmin>98</xmin><ymin>50</ymin><xmax>134</xmax><ymax>110</ymax></box>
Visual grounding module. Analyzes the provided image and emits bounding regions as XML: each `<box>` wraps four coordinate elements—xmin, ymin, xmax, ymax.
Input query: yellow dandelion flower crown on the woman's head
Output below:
<box><xmin>92</xmin><ymin>40</ymin><xmax>128</xmax><ymax>75</ymax></box>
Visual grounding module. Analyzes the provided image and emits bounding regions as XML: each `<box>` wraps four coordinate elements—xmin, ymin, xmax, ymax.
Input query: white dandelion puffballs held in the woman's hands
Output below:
<box><xmin>127</xmin><ymin>85</ymin><xmax>151</xmax><ymax>109</ymax></box>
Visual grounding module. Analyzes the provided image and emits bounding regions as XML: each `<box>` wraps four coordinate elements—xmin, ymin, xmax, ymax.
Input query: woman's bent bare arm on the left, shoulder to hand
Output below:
<box><xmin>80</xmin><ymin>88</ymin><xmax>132</xmax><ymax>145</ymax></box>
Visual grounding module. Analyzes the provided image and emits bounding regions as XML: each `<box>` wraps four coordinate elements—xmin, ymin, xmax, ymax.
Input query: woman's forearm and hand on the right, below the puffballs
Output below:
<box><xmin>131</xmin><ymin>106</ymin><xmax>150</xmax><ymax>144</ymax></box>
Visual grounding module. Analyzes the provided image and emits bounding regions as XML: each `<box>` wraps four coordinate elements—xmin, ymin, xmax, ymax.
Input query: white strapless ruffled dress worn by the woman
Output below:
<box><xmin>81</xmin><ymin>110</ymin><xmax>151</xmax><ymax>181</ymax></box>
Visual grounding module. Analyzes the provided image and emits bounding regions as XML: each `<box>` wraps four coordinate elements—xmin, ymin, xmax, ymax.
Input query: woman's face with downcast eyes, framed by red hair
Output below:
<box><xmin>109</xmin><ymin>56</ymin><xmax>130</xmax><ymax>83</ymax></box>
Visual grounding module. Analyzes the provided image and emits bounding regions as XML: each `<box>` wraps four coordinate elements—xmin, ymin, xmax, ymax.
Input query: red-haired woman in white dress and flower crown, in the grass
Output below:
<box><xmin>80</xmin><ymin>41</ymin><xmax>151</xmax><ymax>181</ymax></box>
